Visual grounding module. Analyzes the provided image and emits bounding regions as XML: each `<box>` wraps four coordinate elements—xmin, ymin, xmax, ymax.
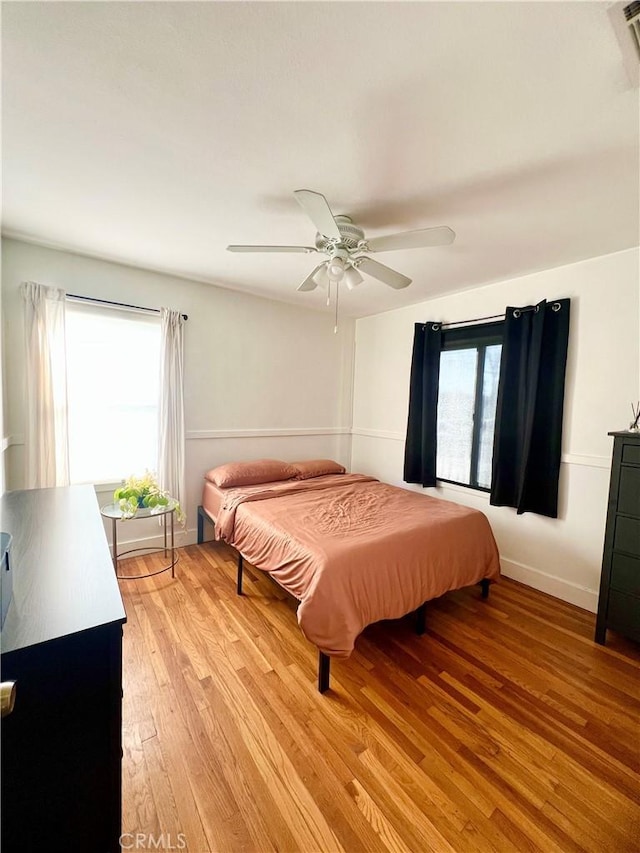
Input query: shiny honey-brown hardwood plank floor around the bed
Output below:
<box><xmin>120</xmin><ymin>543</ymin><xmax>640</xmax><ymax>853</ymax></box>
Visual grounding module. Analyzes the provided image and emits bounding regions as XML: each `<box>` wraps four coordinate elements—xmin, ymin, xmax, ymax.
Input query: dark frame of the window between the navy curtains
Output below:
<box><xmin>436</xmin><ymin>320</ymin><xmax>504</xmax><ymax>494</ymax></box>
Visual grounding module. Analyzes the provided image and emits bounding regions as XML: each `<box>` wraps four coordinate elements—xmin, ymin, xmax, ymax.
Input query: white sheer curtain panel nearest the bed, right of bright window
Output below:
<box><xmin>158</xmin><ymin>308</ymin><xmax>185</xmax><ymax>510</ymax></box>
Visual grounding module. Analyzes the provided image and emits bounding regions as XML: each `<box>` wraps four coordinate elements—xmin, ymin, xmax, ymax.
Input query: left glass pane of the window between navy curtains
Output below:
<box><xmin>436</xmin><ymin>349</ymin><xmax>477</xmax><ymax>483</ymax></box>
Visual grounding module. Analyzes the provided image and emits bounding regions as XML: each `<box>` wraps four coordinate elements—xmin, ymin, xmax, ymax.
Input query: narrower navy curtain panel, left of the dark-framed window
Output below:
<box><xmin>404</xmin><ymin>323</ymin><xmax>442</xmax><ymax>486</ymax></box>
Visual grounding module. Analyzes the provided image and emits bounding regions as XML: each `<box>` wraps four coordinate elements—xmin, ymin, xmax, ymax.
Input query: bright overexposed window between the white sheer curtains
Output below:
<box><xmin>66</xmin><ymin>301</ymin><xmax>160</xmax><ymax>483</ymax></box>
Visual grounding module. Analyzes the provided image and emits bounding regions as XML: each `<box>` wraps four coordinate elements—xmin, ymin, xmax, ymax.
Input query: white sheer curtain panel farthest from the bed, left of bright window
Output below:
<box><xmin>22</xmin><ymin>281</ymin><xmax>69</xmax><ymax>489</ymax></box>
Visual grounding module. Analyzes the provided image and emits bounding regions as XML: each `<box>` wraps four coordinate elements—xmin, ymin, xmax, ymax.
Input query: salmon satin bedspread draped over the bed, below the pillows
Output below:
<box><xmin>203</xmin><ymin>474</ymin><xmax>500</xmax><ymax>658</ymax></box>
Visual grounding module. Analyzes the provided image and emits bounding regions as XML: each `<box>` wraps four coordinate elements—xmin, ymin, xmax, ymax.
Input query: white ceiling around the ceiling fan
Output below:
<box><xmin>2</xmin><ymin>2</ymin><xmax>640</xmax><ymax>316</ymax></box>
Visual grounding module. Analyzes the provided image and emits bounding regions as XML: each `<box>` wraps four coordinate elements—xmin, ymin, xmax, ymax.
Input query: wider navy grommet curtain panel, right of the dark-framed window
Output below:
<box><xmin>491</xmin><ymin>299</ymin><xmax>570</xmax><ymax>518</ymax></box>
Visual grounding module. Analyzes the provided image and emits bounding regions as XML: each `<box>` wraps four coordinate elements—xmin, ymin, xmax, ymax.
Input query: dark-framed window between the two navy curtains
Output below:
<box><xmin>436</xmin><ymin>323</ymin><xmax>503</xmax><ymax>491</ymax></box>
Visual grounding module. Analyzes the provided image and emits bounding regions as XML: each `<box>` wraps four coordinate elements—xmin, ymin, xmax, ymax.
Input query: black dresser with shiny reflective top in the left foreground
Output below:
<box><xmin>0</xmin><ymin>486</ymin><xmax>126</xmax><ymax>853</ymax></box>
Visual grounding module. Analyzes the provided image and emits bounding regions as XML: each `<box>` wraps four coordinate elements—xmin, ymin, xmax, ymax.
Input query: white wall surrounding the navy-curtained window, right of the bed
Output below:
<box><xmin>351</xmin><ymin>250</ymin><xmax>640</xmax><ymax>611</ymax></box>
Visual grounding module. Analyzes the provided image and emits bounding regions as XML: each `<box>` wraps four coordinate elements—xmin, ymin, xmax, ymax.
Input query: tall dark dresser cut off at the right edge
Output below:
<box><xmin>596</xmin><ymin>432</ymin><xmax>640</xmax><ymax>644</ymax></box>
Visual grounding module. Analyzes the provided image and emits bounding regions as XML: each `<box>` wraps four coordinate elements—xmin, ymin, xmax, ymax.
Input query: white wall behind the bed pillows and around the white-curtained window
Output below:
<box><xmin>2</xmin><ymin>239</ymin><xmax>354</xmax><ymax>544</ymax></box>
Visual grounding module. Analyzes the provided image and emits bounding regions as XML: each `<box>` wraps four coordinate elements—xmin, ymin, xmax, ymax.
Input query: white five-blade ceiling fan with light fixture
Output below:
<box><xmin>227</xmin><ymin>190</ymin><xmax>456</xmax><ymax>291</ymax></box>
